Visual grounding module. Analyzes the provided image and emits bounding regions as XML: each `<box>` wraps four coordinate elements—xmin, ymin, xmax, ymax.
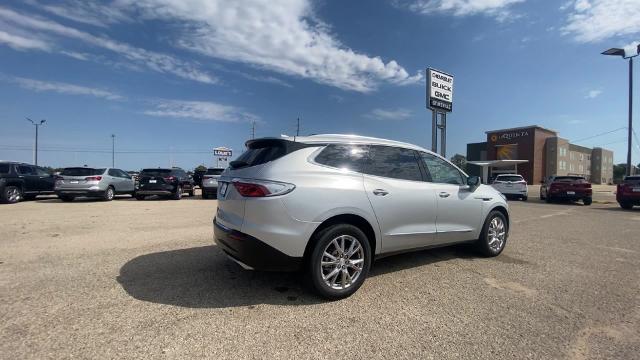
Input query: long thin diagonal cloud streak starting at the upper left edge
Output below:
<box><xmin>0</xmin><ymin>7</ymin><xmax>217</xmax><ymax>84</ymax></box>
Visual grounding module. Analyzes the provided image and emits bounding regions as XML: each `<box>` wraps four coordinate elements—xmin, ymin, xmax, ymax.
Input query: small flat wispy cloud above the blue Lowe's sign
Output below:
<box><xmin>144</xmin><ymin>100</ymin><xmax>259</xmax><ymax>122</ymax></box>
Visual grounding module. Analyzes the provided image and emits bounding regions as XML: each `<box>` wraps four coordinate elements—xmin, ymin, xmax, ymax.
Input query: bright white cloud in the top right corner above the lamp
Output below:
<box><xmin>562</xmin><ymin>0</ymin><xmax>640</xmax><ymax>42</ymax></box>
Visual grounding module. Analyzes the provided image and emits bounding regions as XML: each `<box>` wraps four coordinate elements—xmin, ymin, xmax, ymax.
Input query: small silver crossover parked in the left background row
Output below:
<box><xmin>54</xmin><ymin>167</ymin><xmax>135</xmax><ymax>201</ymax></box>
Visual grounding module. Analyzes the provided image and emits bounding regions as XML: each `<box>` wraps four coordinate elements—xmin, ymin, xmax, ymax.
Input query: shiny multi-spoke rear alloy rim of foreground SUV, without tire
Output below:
<box><xmin>320</xmin><ymin>235</ymin><xmax>365</xmax><ymax>290</ymax></box>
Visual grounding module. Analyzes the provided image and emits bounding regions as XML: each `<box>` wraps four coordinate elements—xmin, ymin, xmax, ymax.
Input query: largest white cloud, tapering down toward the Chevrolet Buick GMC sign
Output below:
<box><xmin>112</xmin><ymin>0</ymin><xmax>422</xmax><ymax>92</ymax></box>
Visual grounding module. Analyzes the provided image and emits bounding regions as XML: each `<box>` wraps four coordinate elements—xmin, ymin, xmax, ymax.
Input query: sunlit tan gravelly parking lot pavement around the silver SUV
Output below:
<box><xmin>0</xmin><ymin>197</ymin><xmax>640</xmax><ymax>359</ymax></box>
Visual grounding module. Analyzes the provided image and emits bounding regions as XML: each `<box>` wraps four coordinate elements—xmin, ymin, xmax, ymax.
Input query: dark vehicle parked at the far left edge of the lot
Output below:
<box><xmin>0</xmin><ymin>161</ymin><xmax>54</xmax><ymax>204</ymax></box>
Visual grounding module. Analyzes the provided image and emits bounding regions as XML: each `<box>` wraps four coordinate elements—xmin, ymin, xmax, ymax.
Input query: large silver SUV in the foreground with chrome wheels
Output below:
<box><xmin>213</xmin><ymin>135</ymin><xmax>509</xmax><ymax>299</ymax></box>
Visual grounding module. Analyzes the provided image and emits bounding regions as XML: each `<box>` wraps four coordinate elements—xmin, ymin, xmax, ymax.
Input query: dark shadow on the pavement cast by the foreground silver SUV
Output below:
<box><xmin>117</xmin><ymin>246</ymin><xmax>484</xmax><ymax>308</ymax></box>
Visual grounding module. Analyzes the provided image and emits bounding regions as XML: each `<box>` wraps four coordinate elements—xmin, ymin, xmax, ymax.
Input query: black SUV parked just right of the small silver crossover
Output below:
<box><xmin>136</xmin><ymin>168</ymin><xmax>194</xmax><ymax>200</ymax></box>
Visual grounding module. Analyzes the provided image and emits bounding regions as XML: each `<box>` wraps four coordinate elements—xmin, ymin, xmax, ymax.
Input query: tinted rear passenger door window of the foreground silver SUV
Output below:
<box><xmin>364</xmin><ymin>146</ymin><xmax>422</xmax><ymax>181</ymax></box>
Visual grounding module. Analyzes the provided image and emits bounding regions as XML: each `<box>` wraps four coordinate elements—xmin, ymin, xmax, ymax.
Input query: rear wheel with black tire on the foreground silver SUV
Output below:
<box><xmin>306</xmin><ymin>224</ymin><xmax>372</xmax><ymax>300</ymax></box>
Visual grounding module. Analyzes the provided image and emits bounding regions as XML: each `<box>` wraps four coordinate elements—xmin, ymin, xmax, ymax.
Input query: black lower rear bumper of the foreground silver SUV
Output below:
<box><xmin>213</xmin><ymin>218</ymin><xmax>302</xmax><ymax>271</ymax></box>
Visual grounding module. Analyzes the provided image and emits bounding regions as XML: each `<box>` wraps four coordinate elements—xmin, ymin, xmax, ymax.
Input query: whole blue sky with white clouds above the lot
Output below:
<box><xmin>0</xmin><ymin>0</ymin><xmax>640</xmax><ymax>169</ymax></box>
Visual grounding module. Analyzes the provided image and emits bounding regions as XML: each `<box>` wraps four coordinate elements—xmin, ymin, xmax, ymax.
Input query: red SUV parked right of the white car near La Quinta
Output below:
<box><xmin>540</xmin><ymin>176</ymin><xmax>593</xmax><ymax>205</ymax></box>
